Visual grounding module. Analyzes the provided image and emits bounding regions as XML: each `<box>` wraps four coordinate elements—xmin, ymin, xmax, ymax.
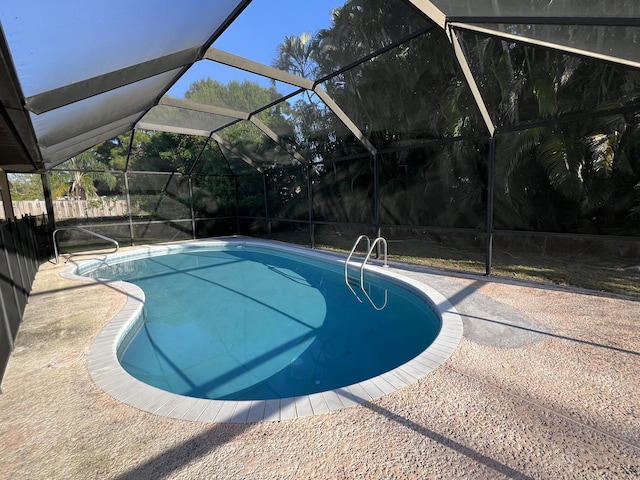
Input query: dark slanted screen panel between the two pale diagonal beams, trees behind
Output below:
<box><xmin>323</xmin><ymin>30</ymin><xmax>486</xmax><ymax>149</ymax></box>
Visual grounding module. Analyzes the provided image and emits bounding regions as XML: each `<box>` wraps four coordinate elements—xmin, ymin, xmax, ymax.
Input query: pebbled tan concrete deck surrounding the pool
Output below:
<box><xmin>0</xmin><ymin>246</ymin><xmax>640</xmax><ymax>479</ymax></box>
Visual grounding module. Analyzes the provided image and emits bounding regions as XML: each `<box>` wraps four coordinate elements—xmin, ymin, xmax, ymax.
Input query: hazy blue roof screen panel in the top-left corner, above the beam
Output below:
<box><xmin>0</xmin><ymin>0</ymin><xmax>242</xmax><ymax>97</ymax></box>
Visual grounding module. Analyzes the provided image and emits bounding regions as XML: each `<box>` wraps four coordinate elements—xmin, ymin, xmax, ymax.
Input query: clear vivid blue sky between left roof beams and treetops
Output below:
<box><xmin>169</xmin><ymin>0</ymin><xmax>345</xmax><ymax>97</ymax></box>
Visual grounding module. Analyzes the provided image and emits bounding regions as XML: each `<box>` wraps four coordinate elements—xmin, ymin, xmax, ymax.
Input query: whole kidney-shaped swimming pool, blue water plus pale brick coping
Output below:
<box><xmin>68</xmin><ymin>238</ymin><xmax>461</xmax><ymax>421</ymax></box>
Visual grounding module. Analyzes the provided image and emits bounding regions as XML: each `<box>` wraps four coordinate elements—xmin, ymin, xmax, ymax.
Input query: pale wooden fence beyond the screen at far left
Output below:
<box><xmin>0</xmin><ymin>199</ymin><xmax>129</xmax><ymax>219</ymax></box>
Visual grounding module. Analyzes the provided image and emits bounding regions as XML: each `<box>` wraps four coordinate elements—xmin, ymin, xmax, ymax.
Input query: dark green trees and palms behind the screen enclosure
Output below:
<box><xmin>41</xmin><ymin>5</ymin><xmax>640</xmax><ymax>240</ymax></box>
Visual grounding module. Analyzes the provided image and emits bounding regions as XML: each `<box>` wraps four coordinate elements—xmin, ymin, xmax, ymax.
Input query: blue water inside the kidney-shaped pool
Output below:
<box><xmin>91</xmin><ymin>246</ymin><xmax>441</xmax><ymax>400</ymax></box>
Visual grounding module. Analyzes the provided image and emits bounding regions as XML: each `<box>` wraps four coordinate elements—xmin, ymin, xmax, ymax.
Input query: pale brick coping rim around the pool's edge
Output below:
<box><xmin>61</xmin><ymin>237</ymin><xmax>463</xmax><ymax>423</ymax></box>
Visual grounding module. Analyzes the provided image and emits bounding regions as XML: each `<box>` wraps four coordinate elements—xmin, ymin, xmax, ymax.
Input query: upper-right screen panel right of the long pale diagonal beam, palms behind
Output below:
<box><xmin>460</xmin><ymin>31</ymin><xmax>640</xmax><ymax>127</ymax></box>
